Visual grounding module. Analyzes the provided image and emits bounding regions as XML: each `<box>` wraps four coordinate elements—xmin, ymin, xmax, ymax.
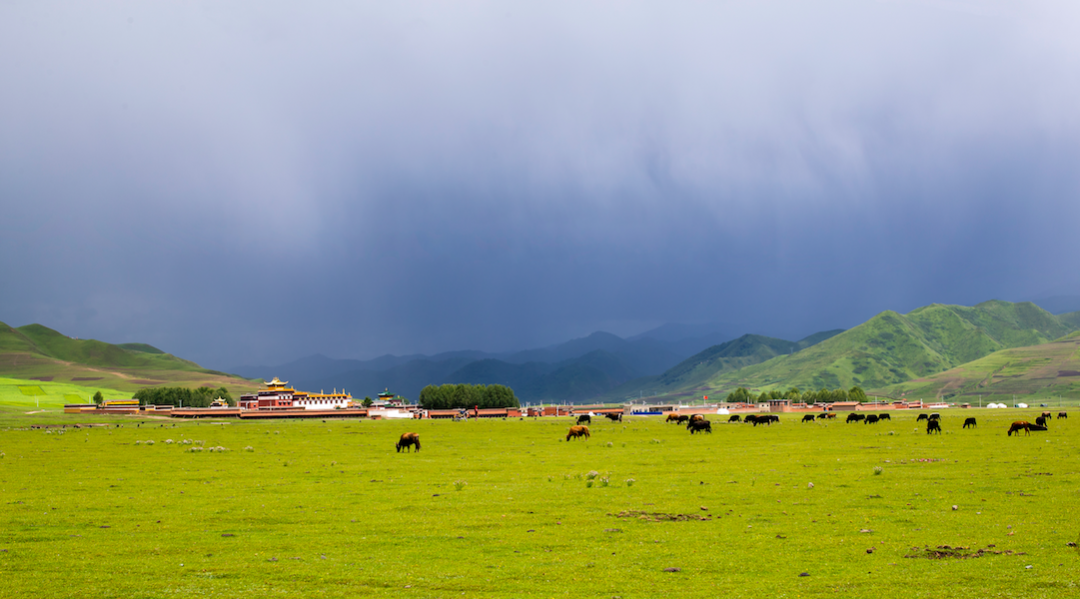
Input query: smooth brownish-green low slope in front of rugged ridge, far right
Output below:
<box><xmin>885</xmin><ymin>332</ymin><xmax>1080</xmax><ymax>403</ymax></box>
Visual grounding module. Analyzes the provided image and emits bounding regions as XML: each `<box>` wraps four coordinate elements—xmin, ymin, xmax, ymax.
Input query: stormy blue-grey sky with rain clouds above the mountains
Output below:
<box><xmin>0</xmin><ymin>0</ymin><xmax>1080</xmax><ymax>368</ymax></box>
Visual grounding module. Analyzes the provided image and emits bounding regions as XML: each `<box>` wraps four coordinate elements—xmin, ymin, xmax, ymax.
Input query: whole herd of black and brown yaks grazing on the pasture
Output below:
<box><xmin>395</xmin><ymin>411</ymin><xmax>1069</xmax><ymax>452</ymax></box>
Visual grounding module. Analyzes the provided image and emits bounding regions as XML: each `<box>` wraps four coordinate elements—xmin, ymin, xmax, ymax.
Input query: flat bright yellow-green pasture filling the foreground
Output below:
<box><xmin>0</xmin><ymin>410</ymin><xmax>1080</xmax><ymax>598</ymax></box>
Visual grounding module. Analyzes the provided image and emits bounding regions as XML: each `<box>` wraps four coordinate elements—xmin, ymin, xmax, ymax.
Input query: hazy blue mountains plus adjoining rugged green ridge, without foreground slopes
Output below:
<box><xmin>234</xmin><ymin>301</ymin><xmax>1080</xmax><ymax>403</ymax></box>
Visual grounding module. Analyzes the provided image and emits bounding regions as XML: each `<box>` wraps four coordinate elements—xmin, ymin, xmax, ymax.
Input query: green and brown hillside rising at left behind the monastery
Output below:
<box><xmin>0</xmin><ymin>323</ymin><xmax>259</xmax><ymax>397</ymax></box>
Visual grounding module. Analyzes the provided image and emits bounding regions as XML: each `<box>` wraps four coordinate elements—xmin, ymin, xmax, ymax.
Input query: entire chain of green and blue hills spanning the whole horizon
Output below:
<box><xmin>0</xmin><ymin>300</ymin><xmax>1080</xmax><ymax>403</ymax></box>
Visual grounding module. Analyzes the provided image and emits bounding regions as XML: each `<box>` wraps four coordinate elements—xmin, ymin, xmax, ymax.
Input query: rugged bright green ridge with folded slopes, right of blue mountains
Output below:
<box><xmin>630</xmin><ymin>301</ymin><xmax>1077</xmax><ymax>397</ymax></box>
